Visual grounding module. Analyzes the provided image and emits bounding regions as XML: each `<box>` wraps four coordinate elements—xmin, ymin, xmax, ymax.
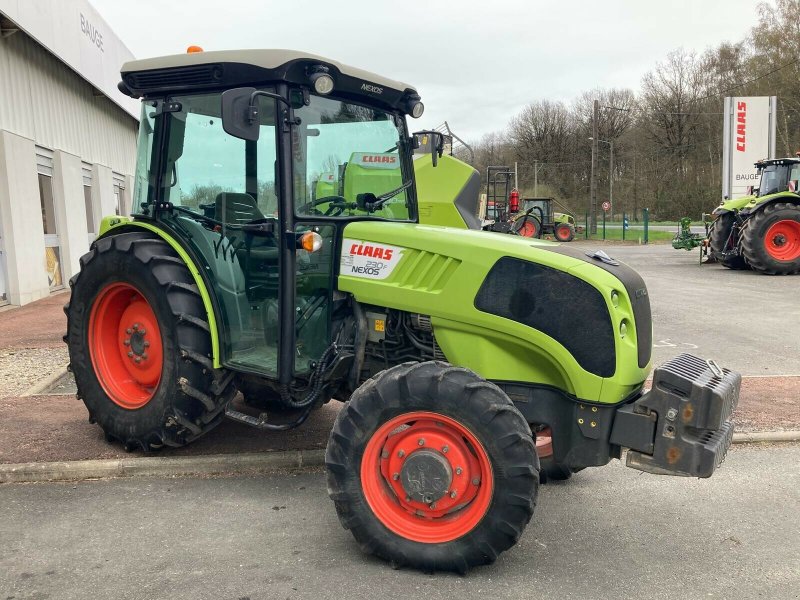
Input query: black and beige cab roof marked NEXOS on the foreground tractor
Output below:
<box><xmin>119</xmin><ymin>50</ymin><xmax>419</xmax><ymax>113</ymax></box>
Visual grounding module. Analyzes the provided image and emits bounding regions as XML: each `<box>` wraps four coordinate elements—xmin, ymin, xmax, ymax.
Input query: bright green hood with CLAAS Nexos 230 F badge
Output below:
<box><xmin>338</xmin><ymin>221</ymin><xmax>652</xmax><ymax>401</ymax></box>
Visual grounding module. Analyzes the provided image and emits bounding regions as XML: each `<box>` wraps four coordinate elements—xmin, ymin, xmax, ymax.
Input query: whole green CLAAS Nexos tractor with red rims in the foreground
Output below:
<box><xmin>65</xmin><ymin>50</ymin><xmax>741</xmax><ymax>572</ymax></box>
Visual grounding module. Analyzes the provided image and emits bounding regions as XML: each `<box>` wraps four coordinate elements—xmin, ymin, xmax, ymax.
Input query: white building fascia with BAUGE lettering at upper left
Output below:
<box><xmin>0</xmin><ymin>0</ymin><xmax>140</xmax><ymax>120</ymax></box>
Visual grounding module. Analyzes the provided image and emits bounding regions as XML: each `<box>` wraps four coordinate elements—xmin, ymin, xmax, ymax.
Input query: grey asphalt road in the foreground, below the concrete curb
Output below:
<box><xmin>0</xmin><ymin>445</ymin><xmax>800</xmax><ymax>600</ymax></box>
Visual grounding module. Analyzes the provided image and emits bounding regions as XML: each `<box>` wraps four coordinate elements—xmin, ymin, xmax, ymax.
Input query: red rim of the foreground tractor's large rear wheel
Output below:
<box><xmin>89</xmin><ymin>283</ymin><xmax>163</xmax><ymax>410</ymax></box>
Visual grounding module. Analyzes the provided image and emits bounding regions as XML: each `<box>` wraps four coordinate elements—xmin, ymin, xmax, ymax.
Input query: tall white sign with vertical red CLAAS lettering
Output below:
<box><xmin>722</xmin><ymin>96</ymin><xmax>777</xmax><ymax>198</ymax></box>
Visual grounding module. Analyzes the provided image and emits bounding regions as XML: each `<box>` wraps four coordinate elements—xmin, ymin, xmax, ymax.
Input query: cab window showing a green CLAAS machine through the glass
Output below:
<box><xmin>292</xmin><ymin>95</ymin><xmax>413</xmax><ymax>220</ymax></box>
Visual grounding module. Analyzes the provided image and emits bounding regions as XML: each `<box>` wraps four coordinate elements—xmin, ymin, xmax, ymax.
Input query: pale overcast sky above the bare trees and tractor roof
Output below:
<box><xmin>91</xmin><ymin>0</ymin><xmax>757</xmax><ymax>140</ymax></box>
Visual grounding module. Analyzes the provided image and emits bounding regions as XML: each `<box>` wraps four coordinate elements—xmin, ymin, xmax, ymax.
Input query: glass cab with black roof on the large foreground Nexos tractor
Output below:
<box><xmin>120</xmin><ymin>50</ymin><xmax>432</xmax><ymax>382</ymax></box>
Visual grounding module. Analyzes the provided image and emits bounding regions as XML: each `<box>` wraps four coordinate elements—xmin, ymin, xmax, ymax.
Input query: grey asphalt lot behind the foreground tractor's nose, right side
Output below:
<box><xmin>574</xmin><ymin>240</ymin><xmax>800</xmax><ymax>376</ymax></box>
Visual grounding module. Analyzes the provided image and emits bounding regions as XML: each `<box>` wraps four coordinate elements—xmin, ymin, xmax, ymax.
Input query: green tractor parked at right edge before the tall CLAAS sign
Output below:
<box><xmin>709</xmin><ymin>157</ymin><xmax>800</xmax><ymax>275</ymax></box>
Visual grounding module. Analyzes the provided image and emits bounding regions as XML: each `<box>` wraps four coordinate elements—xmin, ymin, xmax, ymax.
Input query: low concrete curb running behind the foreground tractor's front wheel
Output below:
<box><xmin>0</xmin><ymin>431</ymin><xmax>800</xmax><ymax>483</ymax></box>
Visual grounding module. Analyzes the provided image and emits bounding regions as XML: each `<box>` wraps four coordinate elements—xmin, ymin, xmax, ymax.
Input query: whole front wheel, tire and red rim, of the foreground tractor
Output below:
<box><xmin>325</xmin><ymin>362</ymin><xmax>539</xmax><ymax>573</ymax></box>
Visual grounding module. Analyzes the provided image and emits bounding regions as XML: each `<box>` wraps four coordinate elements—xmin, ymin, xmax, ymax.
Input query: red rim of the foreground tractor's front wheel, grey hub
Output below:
<box><xmin>361</xmin><ymin>411</ymin><xmax>494</xmax><ymax>544</ymax></box>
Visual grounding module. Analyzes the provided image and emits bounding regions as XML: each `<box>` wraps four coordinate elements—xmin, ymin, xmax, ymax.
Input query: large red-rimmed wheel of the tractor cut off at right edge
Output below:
<box><xmin>741</xmin><ymin>202</ymin><xmax>800</xmax><ymax>275</ymax></box>
